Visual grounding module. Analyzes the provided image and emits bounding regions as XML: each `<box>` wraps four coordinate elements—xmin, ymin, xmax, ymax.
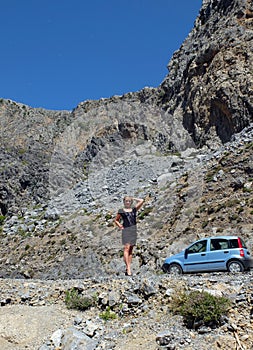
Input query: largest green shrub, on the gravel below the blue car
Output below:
<box><xmin>171</xmin><ymin>291</ymin><xmax>230</xmax><ymax>329</ymax></box>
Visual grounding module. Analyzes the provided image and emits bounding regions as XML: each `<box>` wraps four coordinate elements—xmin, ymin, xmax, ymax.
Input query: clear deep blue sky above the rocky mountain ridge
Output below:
<box><xmin>0</xmin><ymin>0</ymin><xmax>202</xmax><ymax>110</ymax></box>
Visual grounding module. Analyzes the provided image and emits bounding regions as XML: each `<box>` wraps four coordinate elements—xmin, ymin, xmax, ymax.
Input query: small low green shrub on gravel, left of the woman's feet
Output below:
<box><xmin>65</xmin><ymin>288</ymin><xmax>95</xmax><ymax>311</ymax></box>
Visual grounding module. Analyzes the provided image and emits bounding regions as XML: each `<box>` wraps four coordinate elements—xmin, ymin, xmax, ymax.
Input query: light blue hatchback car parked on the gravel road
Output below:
<box><xmin>162</xmin><ymin>236</ymin><xmax>253</xmax><ymax>275</ymax></box>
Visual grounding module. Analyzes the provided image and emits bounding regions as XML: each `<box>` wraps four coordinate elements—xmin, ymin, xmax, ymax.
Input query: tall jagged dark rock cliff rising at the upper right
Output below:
<box><xmin>159</xmin><ymin>0</ymin><xmax>253</xmax><ymax>146</ymax></box>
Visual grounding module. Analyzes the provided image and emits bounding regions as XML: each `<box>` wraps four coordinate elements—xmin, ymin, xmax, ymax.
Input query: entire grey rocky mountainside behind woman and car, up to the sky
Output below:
<box><xmin>0</xmin><ymin>0</ymin><xmax>253</xmax><ymax>278</ymax></box>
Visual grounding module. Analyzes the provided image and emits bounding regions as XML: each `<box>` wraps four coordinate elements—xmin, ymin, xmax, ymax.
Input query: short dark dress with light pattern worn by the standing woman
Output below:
<box><xmin>118</xmin><ymin>208</ymin><xmax>137</xmax><ymax>245</ymax></box>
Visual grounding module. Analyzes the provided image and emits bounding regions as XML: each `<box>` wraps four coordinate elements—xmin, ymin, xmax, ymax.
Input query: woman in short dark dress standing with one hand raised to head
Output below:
<box><xmin>115</xmin><ymin>196</ymin><xmax>144</xmax><ymax>276</ymax></box>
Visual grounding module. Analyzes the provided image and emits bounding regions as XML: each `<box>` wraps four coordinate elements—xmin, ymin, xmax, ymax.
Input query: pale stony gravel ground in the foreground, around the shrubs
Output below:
<box><xmin>0</xmin><ymin>271</ymin><xmax>253</xmax><ymax>350</ymax></box>
